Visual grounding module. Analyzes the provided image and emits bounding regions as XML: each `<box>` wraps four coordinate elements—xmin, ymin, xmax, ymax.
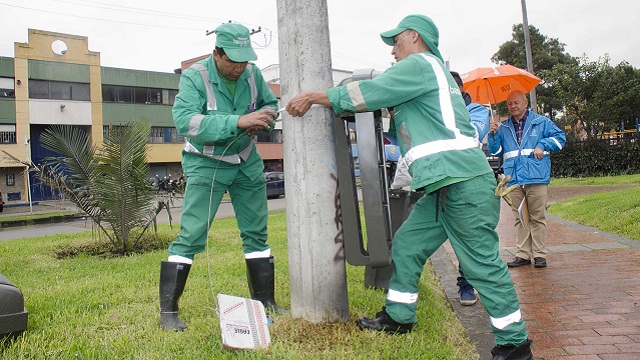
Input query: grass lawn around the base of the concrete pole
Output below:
<box><xmin>0</xmin><ymin>211</ymin><xmax>478</xmax><ymax>359</ymax></box>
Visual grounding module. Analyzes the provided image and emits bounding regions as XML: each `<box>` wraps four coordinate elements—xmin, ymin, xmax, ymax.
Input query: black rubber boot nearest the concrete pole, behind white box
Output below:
<box><xmin>245</xmin><ymin>256</ymin><xmax>286</xmax><ymax>313</ymax></box>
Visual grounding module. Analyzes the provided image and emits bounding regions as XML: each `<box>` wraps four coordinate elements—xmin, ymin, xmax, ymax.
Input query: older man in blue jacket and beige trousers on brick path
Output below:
<box><xmin>489</xmin><ymin>91</ymin><xmax>566</xmax><ymax>268</ymax></box>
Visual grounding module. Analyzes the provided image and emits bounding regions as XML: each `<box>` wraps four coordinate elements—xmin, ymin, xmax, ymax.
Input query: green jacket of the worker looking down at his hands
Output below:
<box><xmin>172</xmin><ymin>56</ymin><xmax>278</xmax><ymax>182</ymax></box>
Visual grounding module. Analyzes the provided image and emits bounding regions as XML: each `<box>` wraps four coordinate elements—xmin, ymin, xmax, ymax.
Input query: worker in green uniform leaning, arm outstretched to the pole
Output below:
<box><xmin>286</xmin><ymin>15</ymin><xmax>533</xmax><ymax>360</ymax></box>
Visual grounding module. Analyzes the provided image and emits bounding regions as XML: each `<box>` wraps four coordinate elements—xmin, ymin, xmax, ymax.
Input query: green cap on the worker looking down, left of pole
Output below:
<box><xmin>214</xmin><ymin>23</ymin><xmax>258</xmax><ymax>62</ymax></box>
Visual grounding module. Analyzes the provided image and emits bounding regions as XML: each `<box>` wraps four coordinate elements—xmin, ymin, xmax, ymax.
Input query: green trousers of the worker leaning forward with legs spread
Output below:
<box><xmin>386</xmin><ymin>173</ymin><xmax>528</xmax><ymax>345</ymax></box>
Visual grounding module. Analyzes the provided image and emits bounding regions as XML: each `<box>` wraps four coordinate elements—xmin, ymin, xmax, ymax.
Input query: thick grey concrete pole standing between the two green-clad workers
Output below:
<box><xmin>277</xmin><ymin>0</ymin><xmax>349</xmax><ymax>323</ymax></box>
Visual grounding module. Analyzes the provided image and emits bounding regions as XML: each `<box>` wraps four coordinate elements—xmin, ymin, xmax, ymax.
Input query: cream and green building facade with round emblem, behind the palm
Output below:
<box><xmin>0</xmin><ymin>29</ymin><xmax>283</xmax><ymax>205</ymax></box>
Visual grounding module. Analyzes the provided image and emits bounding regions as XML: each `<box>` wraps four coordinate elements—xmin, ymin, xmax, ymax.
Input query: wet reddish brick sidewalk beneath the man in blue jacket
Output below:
<box><xmin>432</xmin><ymin>186</ymin><xmax>640</xmax><ymax>360</ymax></box>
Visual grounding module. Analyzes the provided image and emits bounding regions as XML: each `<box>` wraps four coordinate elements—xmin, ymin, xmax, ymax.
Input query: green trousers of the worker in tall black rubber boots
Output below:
<box><xmin>169</xmin><ymin>168</ymin><xmax>269</xmax><ymax>260</ymax></box>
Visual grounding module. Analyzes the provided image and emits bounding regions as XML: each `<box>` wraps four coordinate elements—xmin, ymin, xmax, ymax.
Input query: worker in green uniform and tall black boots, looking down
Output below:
<box><xmin>159</xmin><ymin>23</ymin><xmax>280</xmax><ymax>330</ymax></box>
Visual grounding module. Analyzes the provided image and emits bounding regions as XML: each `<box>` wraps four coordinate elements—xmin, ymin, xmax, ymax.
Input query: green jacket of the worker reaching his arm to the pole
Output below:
<box><xmin>327</xmin><ymin>52</ymin><xmax>492</xmax><ymax>192</ymax></box>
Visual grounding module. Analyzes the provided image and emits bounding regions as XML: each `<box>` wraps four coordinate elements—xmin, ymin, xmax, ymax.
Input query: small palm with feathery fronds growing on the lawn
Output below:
<box><xmin>32</xmin><ymin>122</ymin><xmax>169</xmax><ymax>254</ymax></box>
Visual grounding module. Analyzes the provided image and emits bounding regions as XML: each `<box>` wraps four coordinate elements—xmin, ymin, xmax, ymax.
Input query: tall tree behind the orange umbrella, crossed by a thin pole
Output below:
<box><xmin>491</xmin><ymin>24</ymin><xmax>577</xmax><ymax>119</ymax></box>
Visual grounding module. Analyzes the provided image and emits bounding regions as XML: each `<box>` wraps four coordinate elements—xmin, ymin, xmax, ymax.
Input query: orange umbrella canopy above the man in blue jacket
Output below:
<box><xmin>460</xmin><ymin>65</ymin><xmax>542</xmax><ymax>104</ymax></box>
